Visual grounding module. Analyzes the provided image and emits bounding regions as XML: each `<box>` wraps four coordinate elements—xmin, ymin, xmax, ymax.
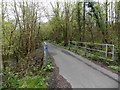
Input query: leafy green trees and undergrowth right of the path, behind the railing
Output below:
<box><xmin>43</xmin><ymin>1</ymin><xmax>120</xmax><ymax>69</ymax></box>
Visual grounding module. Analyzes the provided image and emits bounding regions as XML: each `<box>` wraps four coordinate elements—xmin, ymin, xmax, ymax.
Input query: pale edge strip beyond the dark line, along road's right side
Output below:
<box><xmin>49</xmin><ymin>43</ymin><xmax>120</xmax><ymax>85</ymax></box>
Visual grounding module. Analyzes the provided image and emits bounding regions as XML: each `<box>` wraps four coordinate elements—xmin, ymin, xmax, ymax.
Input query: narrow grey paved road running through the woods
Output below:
<box><xmin>48</xmin><ymin>43</ymin><xmax>118</xmax><ymax>88</ymax></box>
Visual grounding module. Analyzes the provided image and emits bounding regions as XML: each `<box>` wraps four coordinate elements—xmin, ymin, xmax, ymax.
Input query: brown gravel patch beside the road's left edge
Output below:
<box><xmin>48</xmin><ymin>52</ymin><xmax>72</xmax><ymax>90</ymax></box>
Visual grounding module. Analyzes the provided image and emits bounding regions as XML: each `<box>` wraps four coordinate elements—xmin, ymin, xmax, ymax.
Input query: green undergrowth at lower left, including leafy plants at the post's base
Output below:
<box><xmin>2</xmin><ymin>58</ymin><xmax>54</xmax><ymax>88</ymax></box>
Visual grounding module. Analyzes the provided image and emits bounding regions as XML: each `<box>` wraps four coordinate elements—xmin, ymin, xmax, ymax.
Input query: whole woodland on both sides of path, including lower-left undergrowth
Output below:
<box><xmin>0</xmin><ymin>0</ymin><xmax>120</xmax><ymax>88</ymax></box>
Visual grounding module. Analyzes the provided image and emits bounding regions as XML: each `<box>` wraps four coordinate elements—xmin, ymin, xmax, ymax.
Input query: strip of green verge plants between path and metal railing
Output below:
<box><xmin>51</xmin><ymin>41</ymin><xmax>120</xmax><ymax>71</ymax></box>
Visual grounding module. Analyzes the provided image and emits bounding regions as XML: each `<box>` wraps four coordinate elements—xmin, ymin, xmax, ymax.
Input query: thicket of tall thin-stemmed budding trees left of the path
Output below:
<box><xmin>1</xmin><ymin>0</ymin><xmax>42</xmax><ymax>68</ymax></box>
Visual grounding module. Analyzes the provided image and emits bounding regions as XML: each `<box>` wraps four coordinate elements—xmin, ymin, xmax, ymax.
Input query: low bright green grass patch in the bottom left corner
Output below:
<box><xmin>2</xmin><ymin>71</ymin><xmax>49</xmax><ymax>88</ymax></box>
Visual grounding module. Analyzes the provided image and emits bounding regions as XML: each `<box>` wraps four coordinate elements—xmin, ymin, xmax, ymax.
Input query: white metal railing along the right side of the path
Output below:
<box><xmin>68</xmin><ymin>41</ymin><xmax>115</xmax><ymax>60</ymax></box>
